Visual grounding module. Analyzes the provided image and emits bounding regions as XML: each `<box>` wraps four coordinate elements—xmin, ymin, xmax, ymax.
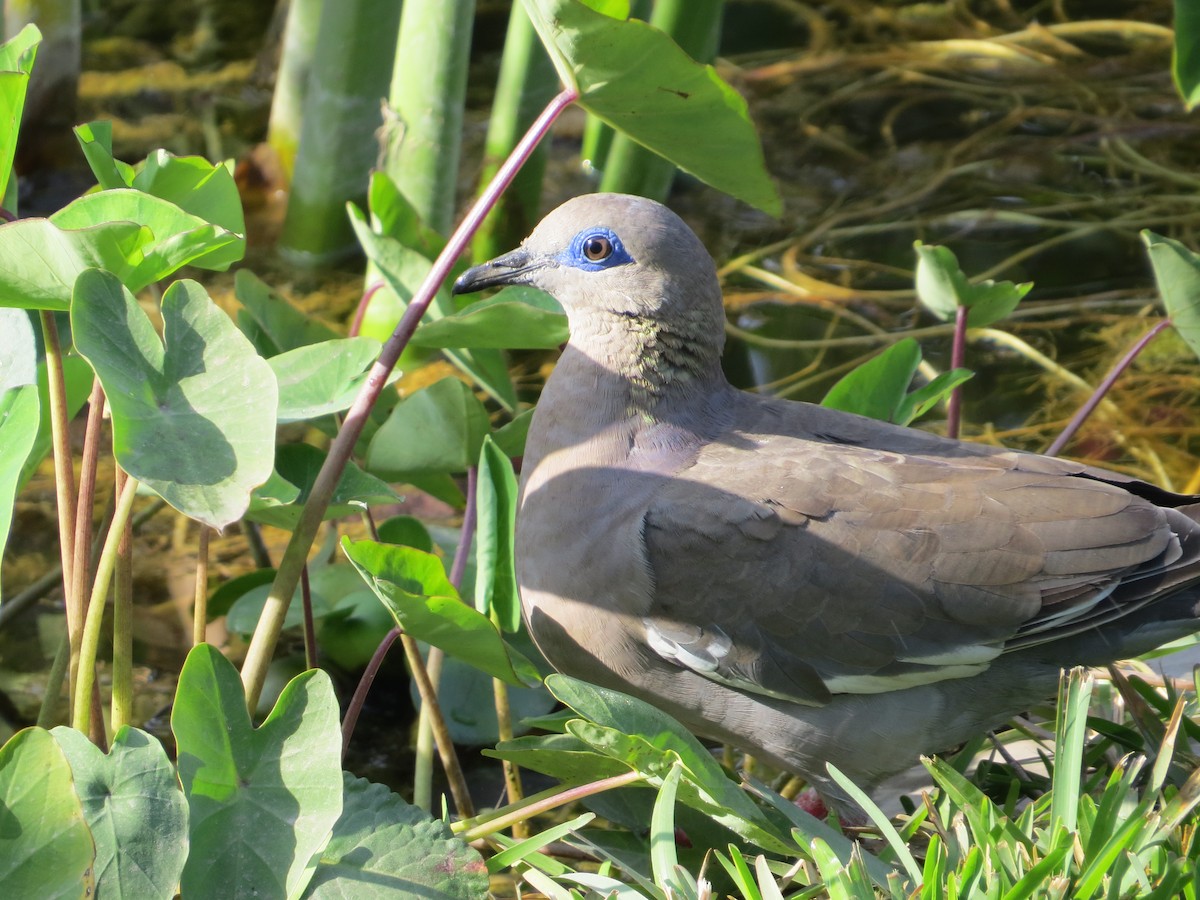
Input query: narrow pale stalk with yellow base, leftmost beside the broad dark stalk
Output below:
<box><xmin>266</xmin><ymin>0</ymin><xmax>324</xmax><ymax>185</ymax></box>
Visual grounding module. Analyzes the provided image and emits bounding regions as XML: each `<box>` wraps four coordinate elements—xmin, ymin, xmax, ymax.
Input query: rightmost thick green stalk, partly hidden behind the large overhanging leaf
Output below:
<box><xmin>600</xmin><ymin>0</ymin><xmax>724</xmax><ymax>202</ymax></box>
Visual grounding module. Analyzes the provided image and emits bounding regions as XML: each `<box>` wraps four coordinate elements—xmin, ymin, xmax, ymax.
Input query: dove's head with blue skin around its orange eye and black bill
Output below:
<box><xmin>454</xmin><ymin>193</ymin><xmax>724</xmax><ymax>358</ymax></box>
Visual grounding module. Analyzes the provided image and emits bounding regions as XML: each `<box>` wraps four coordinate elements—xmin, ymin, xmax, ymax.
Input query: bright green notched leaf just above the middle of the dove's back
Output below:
<box><xmin>821</xmin><ymin>337</ymin><xmax>972</xmax><ymax>425</ymax></box>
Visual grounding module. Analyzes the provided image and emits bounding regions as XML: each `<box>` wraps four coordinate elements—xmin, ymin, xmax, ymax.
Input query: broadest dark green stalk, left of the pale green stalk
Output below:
<box><xmin>280</xmin><ymin>0</ymin><xmax>400</xmax><ymax>265</ymax></box>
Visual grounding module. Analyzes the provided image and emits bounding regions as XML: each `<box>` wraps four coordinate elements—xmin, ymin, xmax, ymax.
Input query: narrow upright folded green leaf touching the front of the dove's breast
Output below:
<box><xmin>475</xmin><ymin>437</ymin><xmax>521</xmax><ymax>634</ymax></box>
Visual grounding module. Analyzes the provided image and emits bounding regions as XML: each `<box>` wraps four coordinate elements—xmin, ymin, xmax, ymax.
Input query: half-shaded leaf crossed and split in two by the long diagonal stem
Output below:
<box><xmin>246</xmin><ymin>444</ymin><xmax>400</xmax><ymax>530</ymax></box>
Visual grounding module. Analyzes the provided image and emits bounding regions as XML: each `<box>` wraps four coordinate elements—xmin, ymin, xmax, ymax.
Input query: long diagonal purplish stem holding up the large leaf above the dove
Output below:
<box><xmin>241</xmin><ymin>88</ymin><xmax>578</xmax><ymax>709</ymax></box>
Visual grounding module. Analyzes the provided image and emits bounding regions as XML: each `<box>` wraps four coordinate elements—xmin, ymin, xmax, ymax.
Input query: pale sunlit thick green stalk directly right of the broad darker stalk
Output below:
<box><xmin>383</xmin><ymin>0</ymin><xmax>475</xmax><ymax>234</ymax></box>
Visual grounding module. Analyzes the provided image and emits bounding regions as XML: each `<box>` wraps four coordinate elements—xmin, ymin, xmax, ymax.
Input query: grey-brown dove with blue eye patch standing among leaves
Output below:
<box><xmin>455</xmin><ymin>194</ymin><xmax>1200</xmax><ymax>803</ymax></box>
